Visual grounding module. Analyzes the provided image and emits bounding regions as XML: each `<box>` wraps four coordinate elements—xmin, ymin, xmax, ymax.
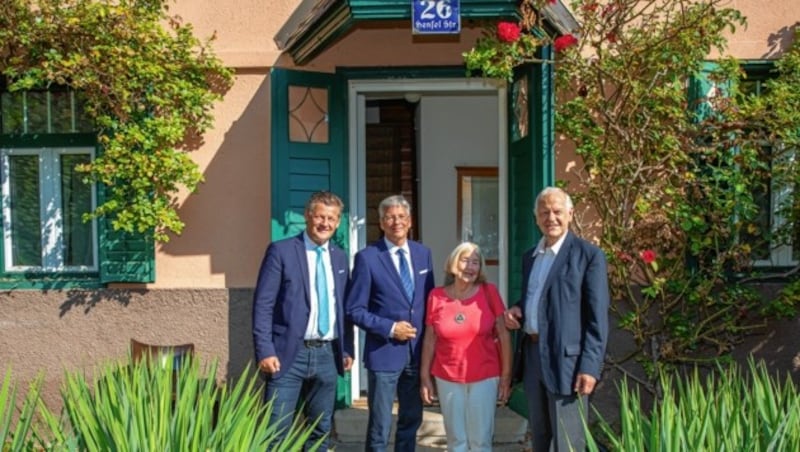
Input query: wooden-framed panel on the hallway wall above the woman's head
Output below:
<box><xmin>456</xmin><ymin>166</ymin><xmax>500</xmax><ymax>265</ymax></box>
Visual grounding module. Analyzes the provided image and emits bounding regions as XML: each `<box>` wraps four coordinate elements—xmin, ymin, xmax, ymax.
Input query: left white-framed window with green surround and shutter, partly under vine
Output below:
<box><xmin>0</xmin><ymin>87</ymin><xmax>154</xmax><ymax>288</ymax></box>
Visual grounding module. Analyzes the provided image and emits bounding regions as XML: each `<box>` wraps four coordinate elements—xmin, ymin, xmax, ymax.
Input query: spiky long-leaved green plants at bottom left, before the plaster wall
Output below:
<box><xmin>0</xmin><ymin>356</ymin><xmax>321</xmax><ymax>452</ymax></box>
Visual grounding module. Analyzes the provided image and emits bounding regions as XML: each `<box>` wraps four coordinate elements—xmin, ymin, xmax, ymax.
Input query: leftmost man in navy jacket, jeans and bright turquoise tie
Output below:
<box><xmin>253</xmin><ymin>192</ymin><xmax>353</xmax><ymax>450</ymax></box>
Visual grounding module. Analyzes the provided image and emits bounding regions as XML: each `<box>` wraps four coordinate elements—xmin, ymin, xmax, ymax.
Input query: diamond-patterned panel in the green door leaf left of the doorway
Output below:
<box><xmin>288</xmin><ymin>86</ymin><xmax>329</xmax><ymax>143</ymax></box>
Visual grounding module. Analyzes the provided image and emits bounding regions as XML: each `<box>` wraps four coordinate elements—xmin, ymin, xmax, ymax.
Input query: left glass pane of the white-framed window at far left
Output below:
<box><xmin>9</xmin><ymin>155</ymin><xmax>42</xmax><ymax>267</ymax></box>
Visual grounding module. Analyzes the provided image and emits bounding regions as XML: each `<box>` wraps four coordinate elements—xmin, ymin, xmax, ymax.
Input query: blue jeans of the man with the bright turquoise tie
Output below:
<box><xmin>264</xmin><ymin>343</ymin><xmax>338</xmax><ymax>450</ymax></box>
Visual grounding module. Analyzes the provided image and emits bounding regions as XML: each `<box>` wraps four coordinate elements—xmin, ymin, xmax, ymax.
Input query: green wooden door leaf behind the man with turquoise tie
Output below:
<box><xmin>270</xmin><ymin>68</ymin><xmax>352</xmax><ymax>409</ymax></box>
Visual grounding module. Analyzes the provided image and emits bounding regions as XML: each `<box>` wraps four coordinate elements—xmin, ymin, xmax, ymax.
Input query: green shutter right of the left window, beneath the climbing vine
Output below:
<box><xmin>97</xmin><ymin>188</ymin><xmax>156</xmax><ymax>283</ymax></box>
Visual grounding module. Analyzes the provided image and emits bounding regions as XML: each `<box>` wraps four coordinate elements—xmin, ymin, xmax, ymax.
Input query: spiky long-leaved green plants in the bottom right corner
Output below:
<box><xmin>588</xmin><ymin>361</ymin><xmax>800</xmax><ymax>452</ymax></box>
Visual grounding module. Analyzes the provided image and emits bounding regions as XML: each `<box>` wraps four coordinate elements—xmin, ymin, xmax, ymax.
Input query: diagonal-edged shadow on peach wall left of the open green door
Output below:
<box><xmin>160</xmin><ymin>69</ymin><xmax>271</xmax><ymax>288</ymax></box>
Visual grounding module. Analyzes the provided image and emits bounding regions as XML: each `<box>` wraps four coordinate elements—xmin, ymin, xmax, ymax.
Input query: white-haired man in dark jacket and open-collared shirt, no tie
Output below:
<box><xmin>504</xmin><ymin>187</ymin><xmax>609</xmax><ymax>452</ymax></box>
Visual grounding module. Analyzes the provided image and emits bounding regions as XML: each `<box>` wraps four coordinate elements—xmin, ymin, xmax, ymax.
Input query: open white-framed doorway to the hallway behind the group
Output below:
<box><xmin>348</xmin><ymin>79</ymin><xmax>507</xmax><ymax>397</ymax></box>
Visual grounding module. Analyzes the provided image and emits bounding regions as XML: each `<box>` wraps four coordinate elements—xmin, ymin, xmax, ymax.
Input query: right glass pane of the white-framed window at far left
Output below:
<box><xmin>61</xmin><ymin>154</ymin><xmax>94</xmax><ymax>267</ymax></box>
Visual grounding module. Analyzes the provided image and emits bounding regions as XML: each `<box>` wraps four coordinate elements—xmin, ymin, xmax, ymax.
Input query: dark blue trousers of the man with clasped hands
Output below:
<box><xmin>366</xmin><ymin>357</ymin><xmax>422</xmax><ymax>452</ymax></box>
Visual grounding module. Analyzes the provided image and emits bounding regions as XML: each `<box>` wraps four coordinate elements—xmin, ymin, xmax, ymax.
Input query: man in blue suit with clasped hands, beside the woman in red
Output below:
<box><xmin>346</xmin><ymin>195</ymin><xmax>434</xmax><ymax>451</ymax></box>
